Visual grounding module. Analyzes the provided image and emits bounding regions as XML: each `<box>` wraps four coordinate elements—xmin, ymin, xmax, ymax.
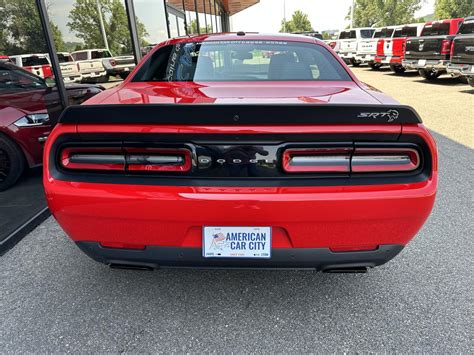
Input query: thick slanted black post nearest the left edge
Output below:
<box><xmin>36</xmin><ymin>0</ymin><xmax>69</xmax><ymax>109</ymax></box>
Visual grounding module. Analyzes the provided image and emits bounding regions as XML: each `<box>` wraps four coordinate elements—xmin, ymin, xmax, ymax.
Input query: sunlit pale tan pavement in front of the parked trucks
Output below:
<box><xmin>351</xmin><ymin>66</ymin><xmax>474</xmax><ymax>148</ymax></box>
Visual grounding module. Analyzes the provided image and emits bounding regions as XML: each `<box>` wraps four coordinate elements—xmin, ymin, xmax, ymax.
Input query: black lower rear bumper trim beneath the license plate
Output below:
<box><xmin>77</xmin><ymin>242</ymin><xmax>403</xmax><ymax>271</ymax></box>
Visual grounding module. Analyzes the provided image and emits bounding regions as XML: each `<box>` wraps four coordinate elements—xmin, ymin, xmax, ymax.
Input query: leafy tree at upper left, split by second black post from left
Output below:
<box><xmin>67</xmin><ymin>0</ymin><xmax>148</xmax><ymax>54</ymax></box>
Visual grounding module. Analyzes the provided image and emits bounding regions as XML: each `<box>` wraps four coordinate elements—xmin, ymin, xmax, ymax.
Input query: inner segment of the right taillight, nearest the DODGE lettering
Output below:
<box><xmin>283</xmin><ymin>148</ymin><xmax>351</xmax><ymax>173</ymax></box>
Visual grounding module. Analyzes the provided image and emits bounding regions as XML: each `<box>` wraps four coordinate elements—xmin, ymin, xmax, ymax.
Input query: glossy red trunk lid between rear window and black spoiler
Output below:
<box><xmin>97</xmin><ymin>81</ymin><xmax>379</xmax><ymax>104</ymax></box>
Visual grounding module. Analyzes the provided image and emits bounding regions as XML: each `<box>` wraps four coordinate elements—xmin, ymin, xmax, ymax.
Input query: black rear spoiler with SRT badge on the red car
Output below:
<box><xmin>59</xmin><ymin>104</ymin><xmax>421</xmax><ymax>125</ymax></box>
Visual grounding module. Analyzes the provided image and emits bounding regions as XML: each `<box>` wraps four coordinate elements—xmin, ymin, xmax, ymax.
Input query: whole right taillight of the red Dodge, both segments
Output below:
<box><xmin>283</xmin><ymin>148</ymin><xmax>420</xmax><ymax>173</ymax></box>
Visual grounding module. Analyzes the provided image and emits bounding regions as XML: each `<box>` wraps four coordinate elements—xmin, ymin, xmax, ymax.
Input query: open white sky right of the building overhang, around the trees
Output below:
<box><xmin>231</xmin><ymin>0</ymin><xmax>435</xmax><ymax>32</ymax></box>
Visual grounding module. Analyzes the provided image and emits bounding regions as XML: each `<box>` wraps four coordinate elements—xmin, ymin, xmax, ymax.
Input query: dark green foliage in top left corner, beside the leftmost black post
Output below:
<box><xmin>0</xmin><ymin>0</ymin><xmax>64</xmax><ymax>55</ymax></box>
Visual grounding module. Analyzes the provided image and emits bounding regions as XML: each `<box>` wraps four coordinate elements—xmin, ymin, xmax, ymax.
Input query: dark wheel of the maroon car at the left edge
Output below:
<box><xmin>0</xmin><ymin>135</ymin><xmax>25</xmax><ymax>191</ymax></box>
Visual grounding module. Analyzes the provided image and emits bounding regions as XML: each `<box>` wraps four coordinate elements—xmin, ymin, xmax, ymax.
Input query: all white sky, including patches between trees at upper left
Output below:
<box><xmin>47</xmin><ymin>0</ymin><xmax>435</xmax><ymax>43</ymax></box>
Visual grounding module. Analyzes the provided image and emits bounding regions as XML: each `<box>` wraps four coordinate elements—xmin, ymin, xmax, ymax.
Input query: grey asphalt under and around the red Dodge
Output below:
<box><xmin>0</xmin><ymin>69</ymin><xmax>474</xmax><ymax>353</ymax></box>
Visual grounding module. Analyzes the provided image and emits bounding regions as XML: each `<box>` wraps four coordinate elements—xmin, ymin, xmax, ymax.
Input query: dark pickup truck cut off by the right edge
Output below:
<box><xmin>448</xmin><ymin>16</ymin><xmax>474</xmax><ymax>86</ymax></box>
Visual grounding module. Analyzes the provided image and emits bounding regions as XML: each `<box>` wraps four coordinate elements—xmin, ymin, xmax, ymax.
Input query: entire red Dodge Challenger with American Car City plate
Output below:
<box><xmin>44</xmin><ymin>32</ymin><xmax>438</xmax><ymax>272</ymax></box>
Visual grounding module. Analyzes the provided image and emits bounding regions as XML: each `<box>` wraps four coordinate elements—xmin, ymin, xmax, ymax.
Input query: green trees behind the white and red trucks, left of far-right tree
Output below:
<box><xmin>349</xmin><ymin>0</ymin><xmax>422</xmax><ymax>27</ymax></box>
